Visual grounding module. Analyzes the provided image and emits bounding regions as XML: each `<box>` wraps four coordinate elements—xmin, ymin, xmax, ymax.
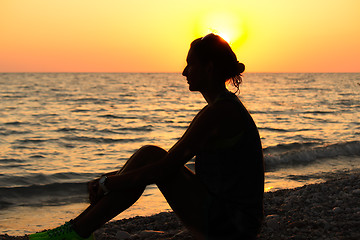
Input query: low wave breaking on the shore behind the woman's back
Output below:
<box><xmin>264</xmin><ymin>141</ymin><xmax>360</xmax><ymax>171</ymax></box>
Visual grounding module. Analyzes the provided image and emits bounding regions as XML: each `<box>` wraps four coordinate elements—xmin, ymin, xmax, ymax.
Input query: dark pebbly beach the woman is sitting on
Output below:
<box><xmin>0</xmin><ymin>171</ymin><xmax>360</xmax><ymax>240</ymax></box>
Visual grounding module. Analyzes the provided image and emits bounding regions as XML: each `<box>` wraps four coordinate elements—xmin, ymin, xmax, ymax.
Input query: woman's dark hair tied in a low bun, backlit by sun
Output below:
<box><xmin>184</xmin><ymin>33</ymin><xmax>245</xmax><ymax>91</ymax></box>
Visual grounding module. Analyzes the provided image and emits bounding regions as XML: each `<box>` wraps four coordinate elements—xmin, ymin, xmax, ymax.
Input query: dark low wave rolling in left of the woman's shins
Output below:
<box><xmin>0</xmin><ymin>172</ymin><xmax>100</xmax><ymax>209</ymax></box>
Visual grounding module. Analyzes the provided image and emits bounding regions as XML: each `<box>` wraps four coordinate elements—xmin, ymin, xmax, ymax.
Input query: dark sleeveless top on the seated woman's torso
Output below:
<box><xmin>195</xmin><ymin>93</ymin><xmax>264</xmax><ymax>236</ymax></box>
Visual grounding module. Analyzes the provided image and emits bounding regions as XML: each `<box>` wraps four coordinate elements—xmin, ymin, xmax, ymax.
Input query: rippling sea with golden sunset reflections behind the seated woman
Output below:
<box><xmin>0</xmin><ymin>73</ymin><xmax>360</xmax><ymax>235</ymax></box>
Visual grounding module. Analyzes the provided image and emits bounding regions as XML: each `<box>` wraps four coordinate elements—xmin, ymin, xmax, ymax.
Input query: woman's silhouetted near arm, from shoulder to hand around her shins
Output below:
<box><xmin>97</xmin><ymin>99</ymin><xmax>241</xmax><ymax>191</ymax></box>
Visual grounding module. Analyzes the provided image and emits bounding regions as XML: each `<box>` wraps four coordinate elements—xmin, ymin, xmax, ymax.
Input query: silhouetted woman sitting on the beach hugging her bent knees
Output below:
<box><xmin>29</xmin><ymin>34</ymin><xmax>264</xmax><ymax>240</ymax></box>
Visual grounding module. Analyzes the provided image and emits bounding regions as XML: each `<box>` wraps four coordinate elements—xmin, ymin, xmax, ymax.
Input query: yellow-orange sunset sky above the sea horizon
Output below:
<box><xmin>0</xmin><ymin>0</ymin><xmax>360</xmax><ymax>72</ymax></box>
